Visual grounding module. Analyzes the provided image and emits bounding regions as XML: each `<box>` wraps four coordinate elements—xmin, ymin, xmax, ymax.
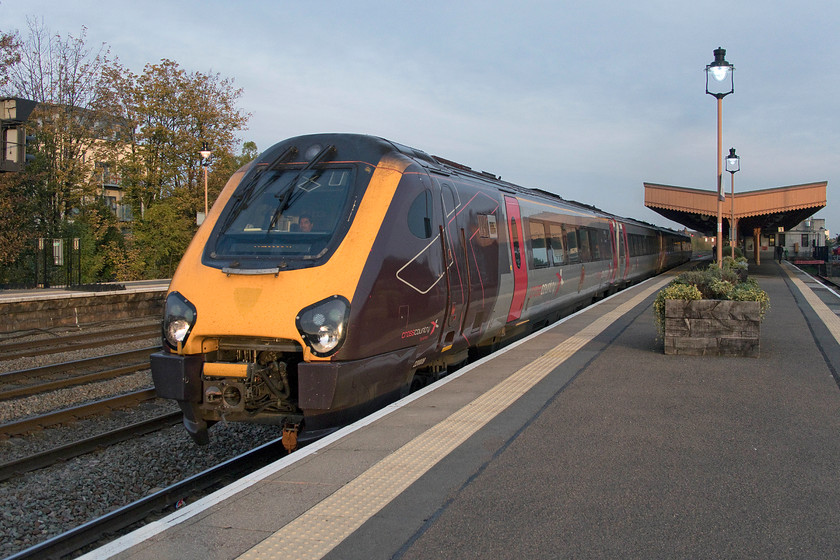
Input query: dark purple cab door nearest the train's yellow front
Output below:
<box><xmin>435</xmin><ymin>181</ymin><xmax>469</xmax><ymax>348</ymax></box>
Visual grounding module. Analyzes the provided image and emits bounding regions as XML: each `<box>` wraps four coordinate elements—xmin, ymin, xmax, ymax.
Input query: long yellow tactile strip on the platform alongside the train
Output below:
<box><xmin>239</xmin><ymin>276</ymin><xmax>671</xmax><ymax>560</ymax></box>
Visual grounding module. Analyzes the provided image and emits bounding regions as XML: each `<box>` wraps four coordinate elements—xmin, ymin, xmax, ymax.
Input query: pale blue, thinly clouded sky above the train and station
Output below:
<box><xmin>0</xmin><ymin>0</ymin><xmax>840</xmax><ymax>236</ymax></box>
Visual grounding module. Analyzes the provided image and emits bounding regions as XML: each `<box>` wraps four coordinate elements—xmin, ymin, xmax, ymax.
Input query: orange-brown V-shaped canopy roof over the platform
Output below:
<box><xmin>645</xmin><ymin>181</ymin><xmax>828</xmax><ymax>237</ymax></box>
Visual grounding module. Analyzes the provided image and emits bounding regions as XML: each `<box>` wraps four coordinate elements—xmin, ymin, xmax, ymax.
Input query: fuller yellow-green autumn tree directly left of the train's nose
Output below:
<box><xmin>99</xmin><ymin>60</ymin><xmax>248</xmax><ymax>277</ymax></box>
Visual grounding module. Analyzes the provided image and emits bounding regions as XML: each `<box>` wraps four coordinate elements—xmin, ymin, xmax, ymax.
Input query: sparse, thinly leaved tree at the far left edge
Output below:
<box><xmin>0</xmin><ymin>19</ymin><xmax>119</xmax><ymax>281</ymax></box>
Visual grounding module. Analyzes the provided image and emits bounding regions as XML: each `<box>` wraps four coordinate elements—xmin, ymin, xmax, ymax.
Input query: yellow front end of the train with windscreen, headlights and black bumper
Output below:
<box><xmin>152</xmin><ymin>135</ymin><xmax>434</xmax><ymax>443</ymax></box>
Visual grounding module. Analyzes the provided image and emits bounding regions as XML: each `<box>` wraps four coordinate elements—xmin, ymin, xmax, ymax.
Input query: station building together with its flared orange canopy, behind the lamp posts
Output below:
<box><xmin>644</xmin><ymin>181</ymin><xmax>829</xmax><ymax>263</ymax></box>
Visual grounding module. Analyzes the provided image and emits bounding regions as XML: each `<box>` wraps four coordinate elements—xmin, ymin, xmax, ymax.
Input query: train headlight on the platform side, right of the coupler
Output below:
<box><xmin>295</xmin><ymin>296</ymin><xmax>350</xmax><ymax>357</ymax></box>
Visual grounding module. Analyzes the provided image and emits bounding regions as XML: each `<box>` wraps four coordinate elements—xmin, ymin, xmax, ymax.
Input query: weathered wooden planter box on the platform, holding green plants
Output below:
<box><xmin>665</xmin><ymin>299</ymin><xmax>761</xmax><ymax>358</ymax></box>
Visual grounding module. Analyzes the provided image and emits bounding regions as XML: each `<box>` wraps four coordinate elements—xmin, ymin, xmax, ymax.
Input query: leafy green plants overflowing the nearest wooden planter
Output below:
<box><xmin>653</xmin><ymin>257</ymin><xmax>770</xmax><ymax>335</ymax></box>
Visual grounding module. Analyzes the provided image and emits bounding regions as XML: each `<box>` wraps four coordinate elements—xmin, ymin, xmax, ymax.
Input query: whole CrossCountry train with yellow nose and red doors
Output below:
<box><xmin>151</xmin><ymin>133</ymin><xmax>691</xmax><ymax>448</ymax></box>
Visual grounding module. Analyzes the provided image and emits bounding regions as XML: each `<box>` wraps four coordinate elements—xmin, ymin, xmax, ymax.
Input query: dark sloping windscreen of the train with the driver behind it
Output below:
<box><xmin>208</xmin><ymin>167</ymin><xmax>355</xmax><ymax>264</ymax></box>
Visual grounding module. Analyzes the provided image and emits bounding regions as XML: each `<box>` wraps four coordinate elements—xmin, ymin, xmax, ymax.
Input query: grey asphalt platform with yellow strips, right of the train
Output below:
<box><xmin>84</xmin><ymin>262</ymin><xmax>840</xmax><ymax>560</ymax></box>
